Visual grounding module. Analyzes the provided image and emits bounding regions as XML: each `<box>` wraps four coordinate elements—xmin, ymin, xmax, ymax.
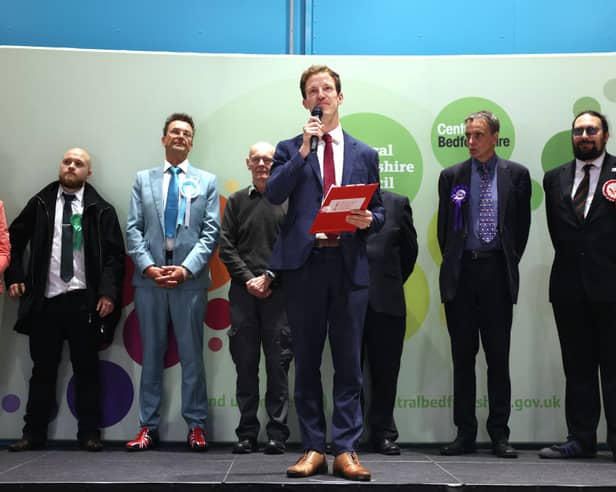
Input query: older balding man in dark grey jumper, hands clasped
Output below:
<box><xmin>220</xmin><ymin>142</ymin><xmax>292</xmax><ymax>454</ymax></box>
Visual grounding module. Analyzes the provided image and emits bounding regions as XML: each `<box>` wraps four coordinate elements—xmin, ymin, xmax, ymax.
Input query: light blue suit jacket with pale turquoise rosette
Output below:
<box><xmin>126</xmin><ymin>164</ymin><xmax>220</xmax><ymax>289</ymax></box>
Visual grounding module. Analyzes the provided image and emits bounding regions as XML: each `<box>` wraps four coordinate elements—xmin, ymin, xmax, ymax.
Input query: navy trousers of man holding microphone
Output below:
<box><xmin>282</xmin><ymin>248</ymin><xmax>368</xmax><ymax>454</ymax></box>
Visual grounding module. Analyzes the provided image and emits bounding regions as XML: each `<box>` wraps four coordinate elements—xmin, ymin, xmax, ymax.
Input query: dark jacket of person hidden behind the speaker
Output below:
<box><xmin>367</xmin><ymin>191</ymin><xmax>417</xmax><ymax>316</ymax></box>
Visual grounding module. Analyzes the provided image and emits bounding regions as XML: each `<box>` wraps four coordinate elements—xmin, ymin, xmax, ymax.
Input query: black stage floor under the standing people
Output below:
<box><xmin>0</xmin><ymin>443</ymin><xmax>616</xmax><ymax>492</ymax></box>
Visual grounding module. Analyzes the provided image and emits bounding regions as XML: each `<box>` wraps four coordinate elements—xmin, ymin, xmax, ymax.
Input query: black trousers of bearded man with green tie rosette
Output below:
<box><xmin>23</xmin><ymin>290</ymin><xmax>100</xmax><ymax>442</ymax></box>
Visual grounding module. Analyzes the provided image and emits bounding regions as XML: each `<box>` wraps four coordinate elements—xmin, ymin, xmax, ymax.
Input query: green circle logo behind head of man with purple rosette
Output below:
<box><xmin>430</xmin><ymin>97</ymin><xmax>515</xmax><ymax>167</ymax></box>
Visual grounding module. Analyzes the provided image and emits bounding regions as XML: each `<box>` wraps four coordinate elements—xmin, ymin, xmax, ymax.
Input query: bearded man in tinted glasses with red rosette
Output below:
<box><xmin>539</xmin><ymin>111</ymin><xmax>616</xmax><ymax>458</ymax></box>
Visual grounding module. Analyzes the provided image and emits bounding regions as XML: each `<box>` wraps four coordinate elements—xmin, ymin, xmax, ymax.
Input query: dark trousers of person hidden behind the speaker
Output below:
<box><xmin>363</xmin><ymin>305</ymin><xmax>406</xmax><ymax>442</ymax></box>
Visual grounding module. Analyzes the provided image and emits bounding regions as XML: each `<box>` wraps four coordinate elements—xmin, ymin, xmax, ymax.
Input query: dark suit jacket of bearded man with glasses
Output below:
<box><xmin>543</xmin><ymin>154</ymin><xmax>616</xmax><ymax>303</ymax></box>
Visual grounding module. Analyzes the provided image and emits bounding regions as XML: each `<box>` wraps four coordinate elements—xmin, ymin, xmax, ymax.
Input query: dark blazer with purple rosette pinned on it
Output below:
<box><xmin>437</xmin><ymin>157</ymin><xmax>531</xmax><ymax>304</ymax></box>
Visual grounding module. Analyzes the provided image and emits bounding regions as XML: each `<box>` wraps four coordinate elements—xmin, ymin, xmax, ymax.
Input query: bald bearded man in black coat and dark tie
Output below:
<box><xmin>5</xmin><ymin>148</ymin><xmax>124</xmax><ymax>451</ymax></box>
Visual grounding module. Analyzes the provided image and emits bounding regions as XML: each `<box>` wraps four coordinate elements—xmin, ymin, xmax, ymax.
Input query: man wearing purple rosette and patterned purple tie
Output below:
<box><xmin>438</xmin><ymin>111</ymin><xmax>531</xmax><ymax>458</ymax></box>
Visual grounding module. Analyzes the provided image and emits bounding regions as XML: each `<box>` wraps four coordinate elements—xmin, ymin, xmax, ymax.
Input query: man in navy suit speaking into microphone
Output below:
<box><xmin>266</xmin><ymin>66</ymin><xmax>385</xmax><ymax>480</ymax></box>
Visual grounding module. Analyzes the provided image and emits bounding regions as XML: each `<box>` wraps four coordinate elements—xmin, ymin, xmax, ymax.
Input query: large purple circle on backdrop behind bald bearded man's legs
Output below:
<box><xmin>66</xmin><ymin>360</ymin><xmax>134</xmax><ymax>428</ymax></box>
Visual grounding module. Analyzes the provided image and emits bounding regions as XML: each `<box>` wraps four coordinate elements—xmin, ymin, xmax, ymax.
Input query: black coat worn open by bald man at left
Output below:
<box><xmin>4</xmin><ymin>181</ymin><xmax>125</xmax><ymax>342</ymax></box>
